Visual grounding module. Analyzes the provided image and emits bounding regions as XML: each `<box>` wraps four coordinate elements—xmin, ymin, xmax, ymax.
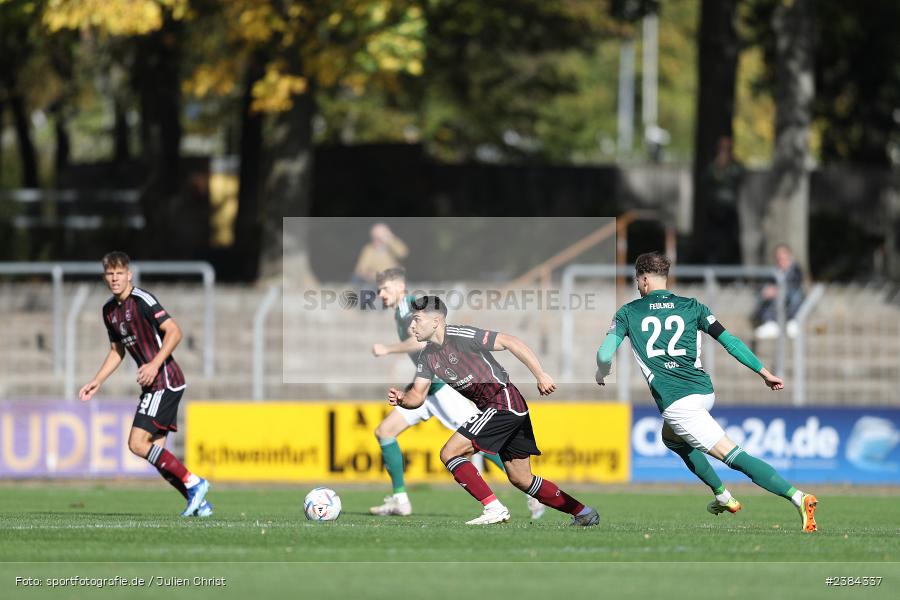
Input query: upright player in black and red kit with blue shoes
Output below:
<box><xmin>78</xmin><ymin>252</ymin><xmax>212</xmax><ymax>517</ymax></box>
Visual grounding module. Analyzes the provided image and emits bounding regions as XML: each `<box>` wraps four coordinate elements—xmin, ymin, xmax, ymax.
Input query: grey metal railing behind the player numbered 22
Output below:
<box><xmin>560</xmin><ymin>264</ymin><xmax>796</xmax><ymax>402</ymax></box>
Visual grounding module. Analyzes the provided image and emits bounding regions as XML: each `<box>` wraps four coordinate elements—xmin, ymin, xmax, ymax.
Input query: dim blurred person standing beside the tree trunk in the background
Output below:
<box><xmin>703</xmin><ymin>136</ymin><xmax>744</xmax><ymax>265</ymax></box>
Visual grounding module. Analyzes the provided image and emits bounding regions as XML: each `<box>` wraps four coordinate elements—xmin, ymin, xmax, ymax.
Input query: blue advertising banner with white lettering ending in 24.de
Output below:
<box><xmin>631</xmin><ymin>406</ymin><xmax>900</xmax><ymax>484</ymax></box>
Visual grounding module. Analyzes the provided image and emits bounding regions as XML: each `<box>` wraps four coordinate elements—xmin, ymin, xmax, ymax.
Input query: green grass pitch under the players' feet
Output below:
<box><xmin>0</xmin><ymin>483</ymin><xmax>900</xmax><ymax>600</ymax></box>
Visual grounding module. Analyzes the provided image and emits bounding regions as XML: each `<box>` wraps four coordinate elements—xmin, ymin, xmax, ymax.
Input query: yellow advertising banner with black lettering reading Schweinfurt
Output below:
<box><xmin>186</xmin><ymin>401</ymin><xmax>631</xmax><ymax>483</ymax></box>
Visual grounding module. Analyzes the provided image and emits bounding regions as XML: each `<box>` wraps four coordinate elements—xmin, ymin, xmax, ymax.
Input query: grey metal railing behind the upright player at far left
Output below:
<box><xmin>0</xmin><ymin>261</ymin><xmax>216</xmax><ymax>376</ymax></box>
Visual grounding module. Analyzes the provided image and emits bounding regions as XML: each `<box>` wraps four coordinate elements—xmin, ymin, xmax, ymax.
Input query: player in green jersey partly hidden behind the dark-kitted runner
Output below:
<box><xmin>369</xmin><ymin>267</ymin><xmax>546</xmax><ymax>519</ymax></box>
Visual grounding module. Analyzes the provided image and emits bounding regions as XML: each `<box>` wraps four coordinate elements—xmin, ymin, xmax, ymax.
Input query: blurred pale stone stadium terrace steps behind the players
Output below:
<box><xmin>0</xmin><ymin>282</ymin><xmax>900</xmax><ymax>406</ymax></box>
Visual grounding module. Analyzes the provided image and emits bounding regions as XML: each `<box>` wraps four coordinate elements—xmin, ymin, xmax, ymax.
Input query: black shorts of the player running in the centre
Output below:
<box><xmin>456</xmin><ymin>408</ymin><xmax>541</xmax><ymax>460</ymax></box>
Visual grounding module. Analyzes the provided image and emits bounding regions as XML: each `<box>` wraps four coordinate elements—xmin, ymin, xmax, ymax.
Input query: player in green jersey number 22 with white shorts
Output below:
<box><xmin>597</xmin><ymin>252</ymin><xmax>817</xmax><ymax>531</ymax></box>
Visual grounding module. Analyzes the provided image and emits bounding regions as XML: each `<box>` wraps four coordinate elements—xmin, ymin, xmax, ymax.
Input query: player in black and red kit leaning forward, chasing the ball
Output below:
<box><xmin>388</xmin><ymin>296</ymin><xmax>600</xmax><ymax>526</ymax></box>
